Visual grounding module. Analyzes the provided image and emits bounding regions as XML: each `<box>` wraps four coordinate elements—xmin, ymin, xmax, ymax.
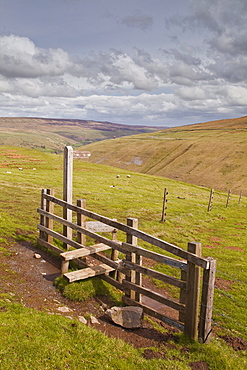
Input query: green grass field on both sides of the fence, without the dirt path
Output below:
<box><xmin>0</xmin><ymin>146</ymin><xmax>247</xmax><ymax>370</ymax></box>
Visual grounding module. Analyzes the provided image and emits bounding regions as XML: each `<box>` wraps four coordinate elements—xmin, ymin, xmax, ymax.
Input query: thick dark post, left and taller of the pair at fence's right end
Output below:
<box><xmin>184</xmin><ymin>242</ymin><xmax>201</xmax><ymax>340</ymax></box>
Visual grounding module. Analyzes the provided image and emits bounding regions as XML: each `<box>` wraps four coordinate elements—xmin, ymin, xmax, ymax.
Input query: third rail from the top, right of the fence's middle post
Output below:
<box><xmin>123</xmin><ymin>260</ymin><xmax>186</xmax><ymax>288</ymax></box>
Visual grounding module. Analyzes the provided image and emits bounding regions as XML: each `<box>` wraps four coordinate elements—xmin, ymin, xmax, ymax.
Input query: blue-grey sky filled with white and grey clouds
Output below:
<box><xmin>0</xmin><ymin>0</ymin><xmax>247</xmax><ymax>126</ymax></box>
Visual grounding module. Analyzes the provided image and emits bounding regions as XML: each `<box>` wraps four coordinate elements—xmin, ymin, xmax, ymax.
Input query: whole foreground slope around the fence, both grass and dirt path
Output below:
<box><xmin>0</xmin><ymin>146</ymin><xmax>247</xmax><ymax>370</ymax></box>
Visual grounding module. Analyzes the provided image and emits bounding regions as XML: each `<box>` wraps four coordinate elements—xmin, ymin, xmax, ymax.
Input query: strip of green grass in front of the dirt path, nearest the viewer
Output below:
<box><xmin>0</xmin><ymin>298</ymin><xmax>243</xmax><ymax>370</ymax></box>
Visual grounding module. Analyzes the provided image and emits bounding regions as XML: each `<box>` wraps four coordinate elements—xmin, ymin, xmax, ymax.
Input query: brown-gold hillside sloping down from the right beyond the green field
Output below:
<box><xmin>82</xmin><ymin>116</ymin><xmax>247</xmax><ymax>194</ymax></box>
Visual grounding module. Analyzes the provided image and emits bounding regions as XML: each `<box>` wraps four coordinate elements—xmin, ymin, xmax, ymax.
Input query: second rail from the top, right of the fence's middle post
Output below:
<box><xmin>122</xmin><ymin>243</ymin><xmax>187</xmax><ymax>270</ymax></box>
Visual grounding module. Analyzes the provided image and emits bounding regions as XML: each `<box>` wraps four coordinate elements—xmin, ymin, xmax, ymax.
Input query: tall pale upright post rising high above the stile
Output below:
<box><xmin>63</xmin><ymin>146</ymin><xmax>73</xmax><ymax>249</ymax></box>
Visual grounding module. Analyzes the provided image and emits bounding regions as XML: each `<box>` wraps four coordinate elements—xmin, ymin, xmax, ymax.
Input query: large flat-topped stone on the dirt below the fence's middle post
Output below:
<box><xmin>105</xmin><ymin>306</ymin><xmax>143</xmax><ymax>329</ymax></box>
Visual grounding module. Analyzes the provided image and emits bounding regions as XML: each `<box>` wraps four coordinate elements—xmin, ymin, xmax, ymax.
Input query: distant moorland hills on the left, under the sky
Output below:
<box><xmin>0</xmin><ymin>117</ymin><xmax>164</xmax><ymax>151</ymax></box>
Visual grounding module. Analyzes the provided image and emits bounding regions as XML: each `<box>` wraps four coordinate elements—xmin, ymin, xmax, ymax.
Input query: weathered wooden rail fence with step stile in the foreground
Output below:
<box><xmin>37</xmin><ymin>189</ymin><xmax>216</xmax><ymax>342</ymax></box>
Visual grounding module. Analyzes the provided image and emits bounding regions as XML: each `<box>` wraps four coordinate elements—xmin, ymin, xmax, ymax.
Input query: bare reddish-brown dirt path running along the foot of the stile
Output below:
<box><xmin>0</xmin><ymin>242</ymin><xmax>180</xmax><ymax>348</ymax></box>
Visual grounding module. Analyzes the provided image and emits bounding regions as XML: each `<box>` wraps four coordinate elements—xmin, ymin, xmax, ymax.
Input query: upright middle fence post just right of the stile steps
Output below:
<box><xmin>126</xmin><ymin>217</ymin><xmax>142</xmax><ymax>302</ymax></box>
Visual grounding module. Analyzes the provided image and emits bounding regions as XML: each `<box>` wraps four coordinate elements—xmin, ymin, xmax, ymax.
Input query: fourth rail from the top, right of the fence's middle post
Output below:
<box><xmin>123</xmin><ymin>280</ymin><xmax>184</xmax><ymax>312</ymax></box>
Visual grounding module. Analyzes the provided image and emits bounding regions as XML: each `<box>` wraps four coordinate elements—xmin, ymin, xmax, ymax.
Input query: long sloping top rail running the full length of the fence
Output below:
<box><xmin>41</xmin><ymin>194</ymin><xmax>208</xmax><ymax>269</ymax></box>
